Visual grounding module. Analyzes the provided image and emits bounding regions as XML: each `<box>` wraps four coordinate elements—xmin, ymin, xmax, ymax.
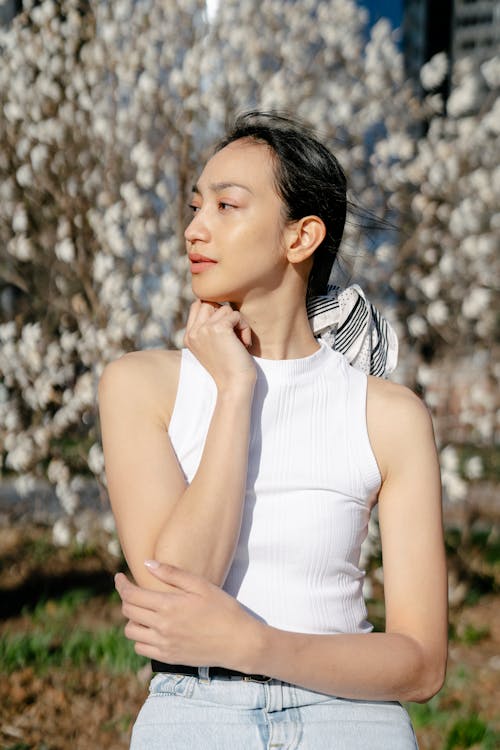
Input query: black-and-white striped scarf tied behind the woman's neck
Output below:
<box><xmin>307</xmin><ymin>284</ymin><xmax>398</xmax><ymax>377</ymax></box>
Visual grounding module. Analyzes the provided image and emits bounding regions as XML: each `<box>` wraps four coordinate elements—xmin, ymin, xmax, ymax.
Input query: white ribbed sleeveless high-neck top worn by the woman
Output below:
<box><xmin>168</xmin><ymin>342</ymin><xmax>380</xmax><ymax>633</ymax></box>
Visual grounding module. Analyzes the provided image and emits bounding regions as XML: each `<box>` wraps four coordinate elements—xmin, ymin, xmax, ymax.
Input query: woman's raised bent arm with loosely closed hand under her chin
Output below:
<box><xmin>99</xmin><ymin>301</ymin><xmax>256</xmax><ymax>589</ymax></box>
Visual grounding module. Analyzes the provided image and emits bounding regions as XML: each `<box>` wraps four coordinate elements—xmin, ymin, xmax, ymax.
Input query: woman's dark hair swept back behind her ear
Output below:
<box><xmin>215</xmin><ymin>111</ymin><xmax>347</xmax><ymax>296</ymax></box>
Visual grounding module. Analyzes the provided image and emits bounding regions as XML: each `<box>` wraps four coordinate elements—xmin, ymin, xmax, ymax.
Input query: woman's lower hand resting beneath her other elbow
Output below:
<box><xmin>115</xmin><ymin>561</ymin><xmax>262</xmax><ymax>671</ymax></box>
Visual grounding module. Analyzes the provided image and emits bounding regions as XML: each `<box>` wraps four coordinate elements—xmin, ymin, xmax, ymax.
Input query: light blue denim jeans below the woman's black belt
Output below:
<box><xmin>130</xmin><ymin>668</ymin><xmax>418</xmax><ymax>750</ymax></box>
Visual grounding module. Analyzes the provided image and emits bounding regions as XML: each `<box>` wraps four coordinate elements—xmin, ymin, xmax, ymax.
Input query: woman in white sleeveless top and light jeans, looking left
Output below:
<box><xmin>99</xmin><ymin>113</ymin><xmax>447</xmax><ymax>750</ymax></box>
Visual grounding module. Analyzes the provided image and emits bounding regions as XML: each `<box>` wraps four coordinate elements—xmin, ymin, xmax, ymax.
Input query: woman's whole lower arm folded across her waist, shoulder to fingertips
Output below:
<box><xmin>117</xmin><ymin>379</ymin><xmax>447</xmax><ymax>701</ymax></box>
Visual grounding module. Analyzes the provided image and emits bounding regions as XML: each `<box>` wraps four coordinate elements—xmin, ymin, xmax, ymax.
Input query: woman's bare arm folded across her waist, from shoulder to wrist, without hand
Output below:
<box><xmin>240</xmin><ymin>378</ymin><xmax>447</xmax><ymax>701</ymax></box>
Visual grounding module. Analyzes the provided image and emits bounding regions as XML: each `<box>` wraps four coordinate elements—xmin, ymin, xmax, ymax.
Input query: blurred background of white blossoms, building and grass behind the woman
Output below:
<box><xmin>0</xmin><ymin>0</ymin><xmax>500</xmax><ymax>750</ymax></box>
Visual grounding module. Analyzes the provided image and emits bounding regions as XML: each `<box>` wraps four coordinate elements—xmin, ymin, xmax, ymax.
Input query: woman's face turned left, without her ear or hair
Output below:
<box><xmin>185</xmin><ymin>140</ymin><xmax>288</xmax><ymax>304</ymax></box>
